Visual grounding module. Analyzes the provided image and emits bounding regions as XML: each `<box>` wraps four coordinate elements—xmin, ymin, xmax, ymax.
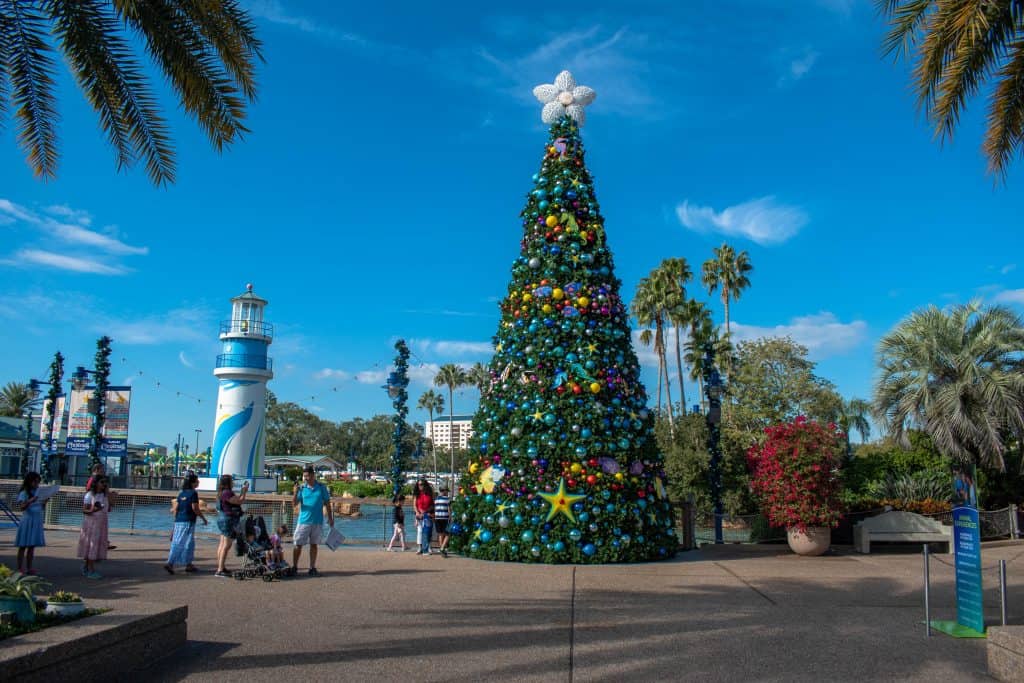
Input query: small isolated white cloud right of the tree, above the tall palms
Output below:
<box><xmin>676</xmin><ymin>196</ymin><xmax>809</xmax><ymax>245</ymax></box>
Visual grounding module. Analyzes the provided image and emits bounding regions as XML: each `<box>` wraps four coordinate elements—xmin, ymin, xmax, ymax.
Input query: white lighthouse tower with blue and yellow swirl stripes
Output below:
<box><xmin>210</xmin><ymin>285</ymin><xmax>273</xmax><ymax>488</ymax></box>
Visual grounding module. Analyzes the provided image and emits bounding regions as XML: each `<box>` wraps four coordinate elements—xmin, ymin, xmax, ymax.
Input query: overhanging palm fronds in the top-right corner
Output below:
<box><xmin>876</xmin><ymin>0</ymin><xmax>1024</xmax><ymax>177</ymax></box>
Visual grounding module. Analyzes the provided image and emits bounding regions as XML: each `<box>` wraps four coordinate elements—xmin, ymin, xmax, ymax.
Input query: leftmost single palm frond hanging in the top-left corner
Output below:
<box><xmin>0</xmin><ymin>0</ymin><xmax>58</xmax><ymax>180</ymax></box>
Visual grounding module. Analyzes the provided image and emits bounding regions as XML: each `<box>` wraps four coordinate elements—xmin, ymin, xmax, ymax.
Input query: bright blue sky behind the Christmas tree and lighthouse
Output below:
<box><xmin>0</xmin><ymin>0</ymin><xmax>1024</xmax><ymax>454</ymax></box>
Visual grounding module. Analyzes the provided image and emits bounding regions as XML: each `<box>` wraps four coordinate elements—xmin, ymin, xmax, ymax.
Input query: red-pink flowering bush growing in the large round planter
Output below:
<box><xmin>746</xmin><ymin>417</ymin><xmax>846</xmax><ymax>531</ymax></box>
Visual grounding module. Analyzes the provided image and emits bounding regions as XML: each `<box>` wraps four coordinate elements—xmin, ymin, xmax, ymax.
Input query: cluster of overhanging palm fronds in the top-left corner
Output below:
<box><xmin>0</xmin><ymin>0</ymin><xmax>263</xmax><ymax>185</ymax></box>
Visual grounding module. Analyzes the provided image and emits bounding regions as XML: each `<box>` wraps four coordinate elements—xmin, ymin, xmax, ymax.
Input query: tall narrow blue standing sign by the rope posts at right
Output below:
<box><xmin>953</xmin><ymin>465</ymin><xmax>985</xmax><ymax>633</ymax></box>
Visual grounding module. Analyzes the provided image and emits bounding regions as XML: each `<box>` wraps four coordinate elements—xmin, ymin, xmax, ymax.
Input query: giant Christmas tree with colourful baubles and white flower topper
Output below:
<box><xmin>452</xmin><ymin>72</ymin><xmax>678</xmax><ymax>563</ymax></box>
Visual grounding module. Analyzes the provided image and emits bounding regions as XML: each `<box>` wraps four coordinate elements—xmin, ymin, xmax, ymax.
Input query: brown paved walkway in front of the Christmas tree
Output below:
<box><xmin>0</xmin><ymin>531</ymin><xmax>1024</xmax><ymax>683</ymax></box>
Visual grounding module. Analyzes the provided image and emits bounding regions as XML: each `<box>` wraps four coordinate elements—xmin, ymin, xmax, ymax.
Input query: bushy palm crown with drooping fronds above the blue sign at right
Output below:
<box><xmin>873</xmin><ymin>301</ymin><xmax>1024</xmax><ymax>470</ymax></box>
